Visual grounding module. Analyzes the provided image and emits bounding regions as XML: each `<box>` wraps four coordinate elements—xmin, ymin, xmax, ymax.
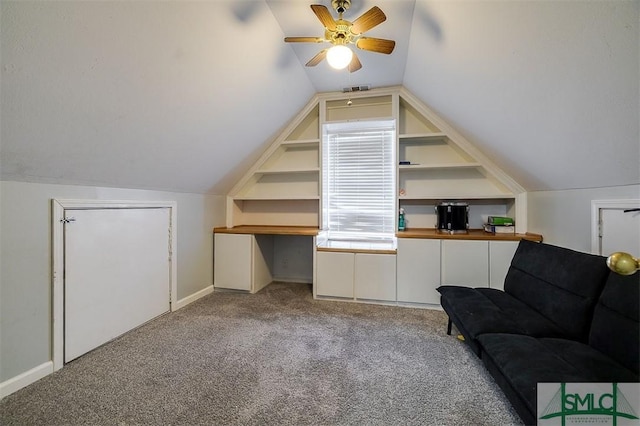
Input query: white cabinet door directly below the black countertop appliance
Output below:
<box><xmin>442</xmin><ymin>240</ymin><xmax>489</xmax><ymax>287</ymax></box>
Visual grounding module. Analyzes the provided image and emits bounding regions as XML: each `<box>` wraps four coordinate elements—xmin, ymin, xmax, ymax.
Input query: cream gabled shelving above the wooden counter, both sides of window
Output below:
<box><xmin>227</xmin><ymin>87</ymin><xmax>527</xmax><ymax>233</ymax></box>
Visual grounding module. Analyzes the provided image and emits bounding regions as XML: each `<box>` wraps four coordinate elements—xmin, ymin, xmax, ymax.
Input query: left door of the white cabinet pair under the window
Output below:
<box><xmin>316</xmin><ymin>251</ymin><xmax>354</xmax><ymax>298</ymax></box>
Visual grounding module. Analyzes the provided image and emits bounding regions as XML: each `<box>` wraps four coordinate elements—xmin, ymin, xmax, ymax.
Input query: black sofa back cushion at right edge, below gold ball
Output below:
<box><xmin>589</xmin><ymin>272</ymin><xmax>640</xmax><ymax>374</ymax></box>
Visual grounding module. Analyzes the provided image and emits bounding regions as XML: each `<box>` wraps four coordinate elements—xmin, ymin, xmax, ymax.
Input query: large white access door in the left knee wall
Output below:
<box><xmin>64</xmin><ymin>208</ymin><xmax>171</xmax><ymax>362</ymax></box>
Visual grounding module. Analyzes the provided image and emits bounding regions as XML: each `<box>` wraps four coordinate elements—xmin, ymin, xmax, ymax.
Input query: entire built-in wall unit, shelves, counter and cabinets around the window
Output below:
<box><xmin>214</xmin><ymin>87</ymin><xmax>542</xmax><ymax>307</ymax></box>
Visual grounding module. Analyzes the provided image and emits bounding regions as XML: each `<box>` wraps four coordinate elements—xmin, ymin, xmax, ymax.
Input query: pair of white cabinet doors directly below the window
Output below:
<box><xmin>315</xmin><ymin>251</ymin><xmax>396</xmax><ymax>301</ymax></box>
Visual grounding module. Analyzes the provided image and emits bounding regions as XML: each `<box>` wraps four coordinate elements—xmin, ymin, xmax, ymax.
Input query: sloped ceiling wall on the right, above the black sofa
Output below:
<box><xmin>404</xmin><ymin>0</ymin><xmax>640</xmax><ymax>190</ymax></box>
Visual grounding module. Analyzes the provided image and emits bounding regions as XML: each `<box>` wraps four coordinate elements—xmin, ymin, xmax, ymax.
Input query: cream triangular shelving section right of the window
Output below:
<box><xmin>397</xmin><ymin>88</ymin><xmax>526</xmax><ymax>232</ymax></box>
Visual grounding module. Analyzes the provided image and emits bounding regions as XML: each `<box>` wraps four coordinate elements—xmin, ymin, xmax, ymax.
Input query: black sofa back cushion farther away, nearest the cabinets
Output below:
<box><xmin>504</xmin><ymin>240</ymin><xmax>609</xmax><ymax>343</ymax></box>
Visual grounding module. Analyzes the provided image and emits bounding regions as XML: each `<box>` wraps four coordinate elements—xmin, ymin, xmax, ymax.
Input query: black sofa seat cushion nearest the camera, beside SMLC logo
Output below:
<box><xmin>478</xmin><ymin>333</ymin><xmax>639</xmax><ymax>420</ymax></box>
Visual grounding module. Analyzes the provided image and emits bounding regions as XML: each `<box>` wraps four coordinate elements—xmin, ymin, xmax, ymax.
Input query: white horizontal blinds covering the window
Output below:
<box><xmin>322</xmin><ymin>120</ymin><xmax>396</xmax><ymax>240</ymax></box>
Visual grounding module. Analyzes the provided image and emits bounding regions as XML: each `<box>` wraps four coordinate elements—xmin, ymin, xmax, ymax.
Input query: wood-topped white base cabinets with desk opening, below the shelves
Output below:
<box><xmin>213</xmin><ymin>225</ymin><xmax>542</xmax><ymax>307</ymax></box>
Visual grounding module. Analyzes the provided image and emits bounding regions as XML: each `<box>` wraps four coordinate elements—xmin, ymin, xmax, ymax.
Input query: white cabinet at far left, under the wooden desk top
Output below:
<box><xmin>213</xmin><ymin>234</ymin><xmax>273</xmax><ymax>293</ymax></box>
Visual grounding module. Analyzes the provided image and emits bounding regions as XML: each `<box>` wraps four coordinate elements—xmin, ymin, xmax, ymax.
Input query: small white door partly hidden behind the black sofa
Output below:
<box><xmin>600</xmin><ymin>206</ymin><xmax>640</xmax><ymax>257</ymax></box>
